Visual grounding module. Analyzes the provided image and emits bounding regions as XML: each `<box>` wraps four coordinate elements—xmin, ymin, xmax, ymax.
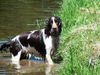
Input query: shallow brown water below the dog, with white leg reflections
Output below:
<box><xmin>0</xmin><ymin>56</ymin><xmax>58</xmax><ymax>75</ymax></box>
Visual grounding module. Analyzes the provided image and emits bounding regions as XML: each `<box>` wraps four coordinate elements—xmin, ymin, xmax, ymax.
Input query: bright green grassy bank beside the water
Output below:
<box><xmin>55</xmin><ymin>0</ymin><xmax>100</xmax><ymax>75</ymax></box>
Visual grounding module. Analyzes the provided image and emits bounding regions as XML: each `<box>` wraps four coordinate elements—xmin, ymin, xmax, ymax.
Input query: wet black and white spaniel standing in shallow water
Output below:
<box><xmin>0</xmin><ymin>17</ymin><xmax>62</xmax><ymax>64</ymax></box>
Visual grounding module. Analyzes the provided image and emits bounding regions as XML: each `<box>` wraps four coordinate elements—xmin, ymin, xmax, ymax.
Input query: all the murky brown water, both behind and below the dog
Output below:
<box><xmin>0</xmin><ymin>0</ymin><xmax>61</xmax><ymax>75</ymax></box>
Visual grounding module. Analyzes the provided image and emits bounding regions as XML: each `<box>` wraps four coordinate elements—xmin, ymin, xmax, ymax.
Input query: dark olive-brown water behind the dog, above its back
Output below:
<box><xmin>0</xmin><ymin>0</ymin><xmax>61</xmax><ymax>40</ymax></box>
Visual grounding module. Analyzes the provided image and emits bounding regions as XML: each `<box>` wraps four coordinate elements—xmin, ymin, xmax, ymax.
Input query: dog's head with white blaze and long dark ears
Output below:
<box><xmin>45</xmin><ymin>16</ymin><xmax>62</xmax><ymax>36</ymax></box>
